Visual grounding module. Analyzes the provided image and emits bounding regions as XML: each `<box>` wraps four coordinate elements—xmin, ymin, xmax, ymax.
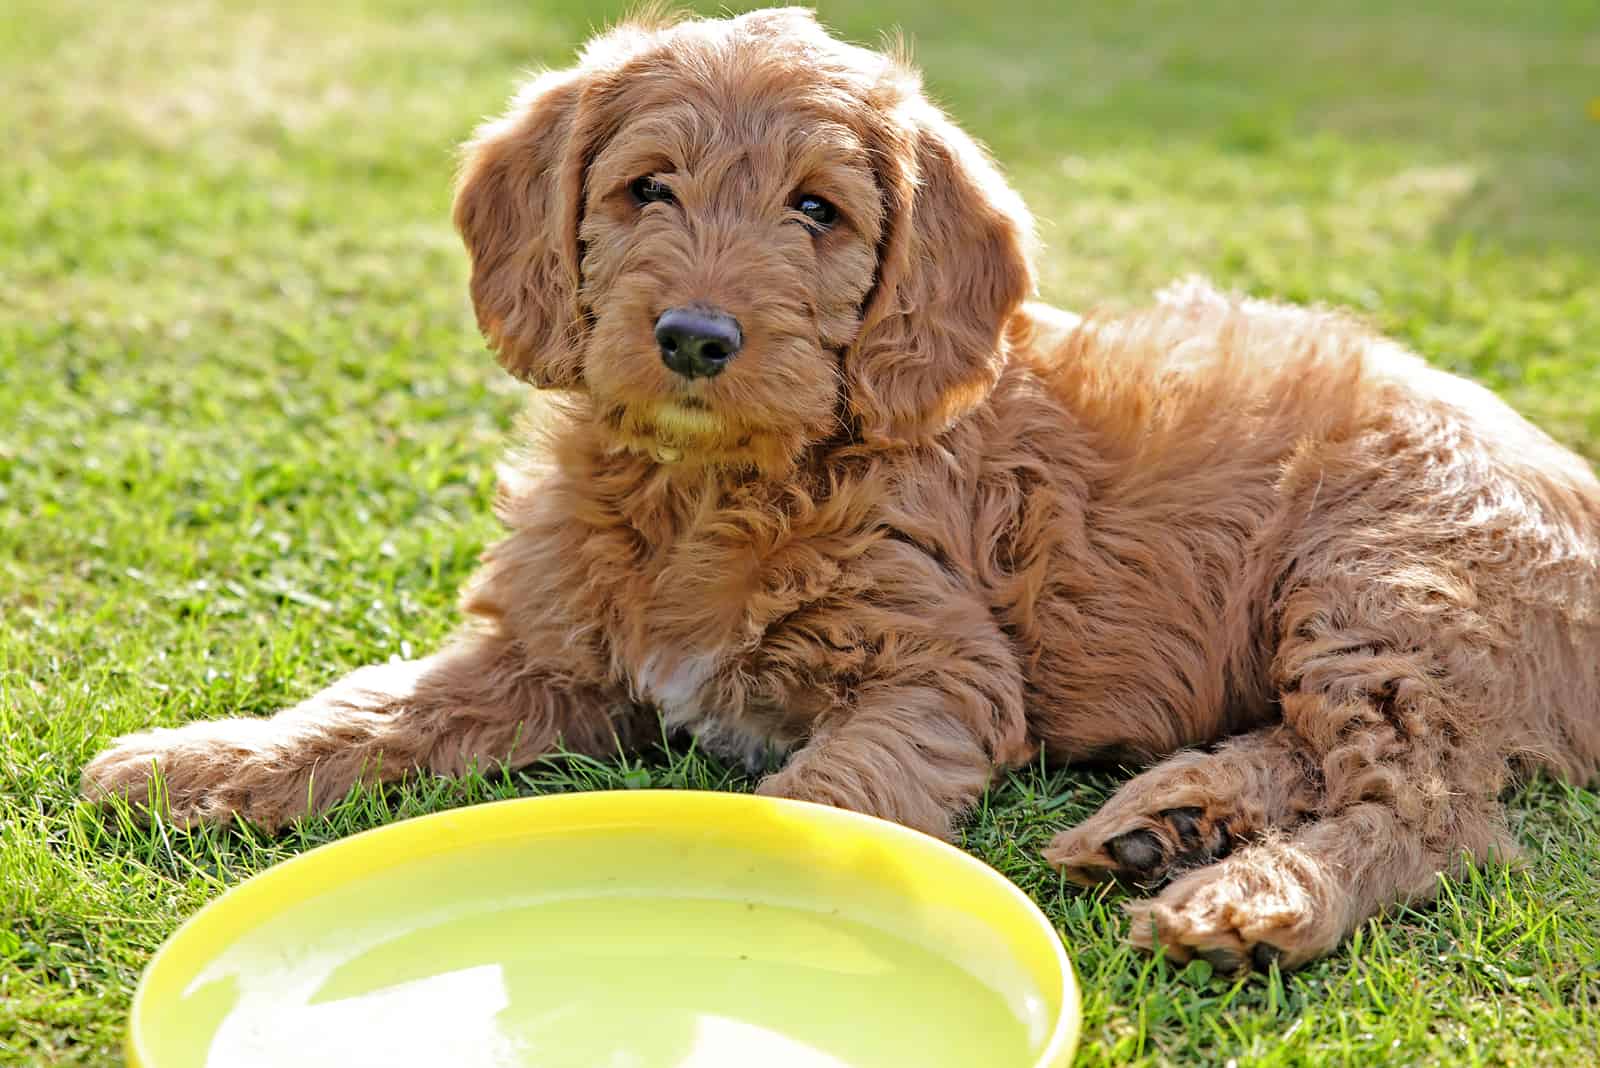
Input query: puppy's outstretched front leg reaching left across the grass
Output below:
<box><xmin>83</xmin><ymin>636</ymin><xmax>630</xmax><ymax>830</ymax></box>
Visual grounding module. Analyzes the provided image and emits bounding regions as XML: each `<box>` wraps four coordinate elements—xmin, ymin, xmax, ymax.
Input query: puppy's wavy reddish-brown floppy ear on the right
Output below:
<box><xmin>845</xmin><ymin>93</ymin><xmax>1034</xmax><ymax>443</ymax></box>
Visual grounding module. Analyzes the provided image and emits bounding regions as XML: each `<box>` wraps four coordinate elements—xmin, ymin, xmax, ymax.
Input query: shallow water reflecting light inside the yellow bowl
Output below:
<box><xmin>154</xmin><ymin>831</ymin><xmax>1042</xmax><ymax>1068</ymax></box>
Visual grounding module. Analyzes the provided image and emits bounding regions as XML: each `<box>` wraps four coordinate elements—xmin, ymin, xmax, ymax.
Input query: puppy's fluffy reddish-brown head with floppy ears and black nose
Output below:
<box><xmin>454</xmin><ymin>10</ymin><xmax>1032</xmax><ymax>467</ymax></box>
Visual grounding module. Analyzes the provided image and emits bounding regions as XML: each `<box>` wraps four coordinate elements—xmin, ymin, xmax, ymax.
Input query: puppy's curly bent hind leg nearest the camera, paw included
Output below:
<box><xmin>1130</xmin><ymin>590</ymin><xmax>1515</xmax><ymax>970</ymax></box>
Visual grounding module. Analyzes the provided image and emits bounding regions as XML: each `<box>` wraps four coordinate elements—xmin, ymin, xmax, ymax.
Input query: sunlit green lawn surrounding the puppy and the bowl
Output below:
<box><xmin>0</xmin><ymin>0</ymin><xmax>1600</xmax><ymax>1065</ymax></box>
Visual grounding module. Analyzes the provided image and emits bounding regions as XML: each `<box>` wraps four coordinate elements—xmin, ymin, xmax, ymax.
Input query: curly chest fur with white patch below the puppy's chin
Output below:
<box><xmin>506</xmin><ymin>444</ymin><xmax>882</xmax><ymax>769</ymax></box>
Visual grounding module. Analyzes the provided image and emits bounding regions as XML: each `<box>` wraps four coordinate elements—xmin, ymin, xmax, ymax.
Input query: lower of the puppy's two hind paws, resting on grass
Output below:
<box><xmin>1126</xmin><ymin>846</ymin><xmax>1342</xmax><ymax>975</ymax></box>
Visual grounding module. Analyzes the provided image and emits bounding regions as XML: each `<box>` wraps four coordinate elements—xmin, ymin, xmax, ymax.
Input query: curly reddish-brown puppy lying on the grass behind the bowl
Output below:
<box><xmin>83</xmin><ymin>10</ymin><xmax>1600</xmax><ymax>972</ymax></box>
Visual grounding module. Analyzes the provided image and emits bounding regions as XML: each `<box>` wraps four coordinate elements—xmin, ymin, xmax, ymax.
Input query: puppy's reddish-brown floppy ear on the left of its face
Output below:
<box><xmin>454</xmin><ymin>67</ymin><xmax>590</xmax><ymax>389</ymax></box>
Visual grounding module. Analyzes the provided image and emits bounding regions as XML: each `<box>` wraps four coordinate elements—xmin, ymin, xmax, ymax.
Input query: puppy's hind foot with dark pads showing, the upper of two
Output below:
<box><xmin>1045</xmin><ymin>726</ymin><xmax>1320</xmax><ymax>887</ymax></box>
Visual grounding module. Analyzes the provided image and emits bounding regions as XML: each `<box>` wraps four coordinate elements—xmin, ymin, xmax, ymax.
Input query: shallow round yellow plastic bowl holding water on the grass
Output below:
<box><xmin>128</xmin><ymin>790</ymin><xmax>1078</xmax><ymax>1068</ymax></box>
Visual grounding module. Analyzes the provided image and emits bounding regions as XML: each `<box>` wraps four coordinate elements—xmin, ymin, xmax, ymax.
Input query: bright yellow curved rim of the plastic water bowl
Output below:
<box><xmin>123</xmin><ymin>788</ymin><xmax>1082</xmax><ymax>1068</ymax></box>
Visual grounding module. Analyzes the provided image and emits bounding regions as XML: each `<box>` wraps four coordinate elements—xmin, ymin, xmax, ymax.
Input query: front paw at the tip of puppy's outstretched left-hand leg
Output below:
<box><xmin>80</xmin><ymin>719</ymin><xmax>282</xmax><ymax>828</ymax></box>
